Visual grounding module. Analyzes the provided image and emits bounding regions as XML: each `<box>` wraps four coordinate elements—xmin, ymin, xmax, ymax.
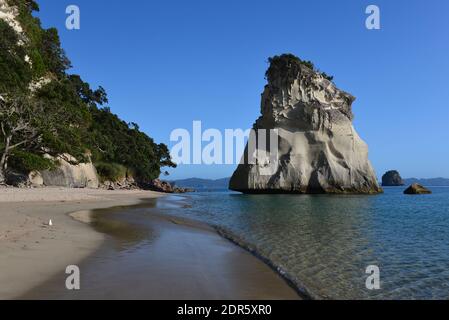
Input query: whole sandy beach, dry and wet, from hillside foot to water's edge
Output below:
<box><xmin>0</xmin><ymin>191</ymin><xmax>299</xmax><ymax>299</ymax></box>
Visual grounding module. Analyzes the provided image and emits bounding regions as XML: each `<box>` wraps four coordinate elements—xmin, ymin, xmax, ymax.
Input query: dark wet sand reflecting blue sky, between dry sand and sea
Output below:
<box><xmin>23</xmin><ymin>198</ymin><xmax>299</xmax><ymax>299</ymax></box>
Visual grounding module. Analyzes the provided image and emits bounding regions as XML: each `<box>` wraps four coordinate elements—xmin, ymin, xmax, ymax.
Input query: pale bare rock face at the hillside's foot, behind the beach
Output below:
<box><xmin>40</xmin><ymin>154</ymin><xmax>100</xmax><ymax>189</ymax></box>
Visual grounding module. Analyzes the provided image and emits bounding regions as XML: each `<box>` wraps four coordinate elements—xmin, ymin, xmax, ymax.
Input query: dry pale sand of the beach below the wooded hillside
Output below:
<box><xmin>0</xmin><ymin>188</ymin><xmax>161</xmax><ymax>299</ymax></box>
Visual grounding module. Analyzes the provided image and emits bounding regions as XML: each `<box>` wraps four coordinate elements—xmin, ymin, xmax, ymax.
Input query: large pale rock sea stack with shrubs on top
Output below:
<box><xmin>229</xmin><ymin>54</ymin><xmax>382</xmax><ymax>194</ymax></box>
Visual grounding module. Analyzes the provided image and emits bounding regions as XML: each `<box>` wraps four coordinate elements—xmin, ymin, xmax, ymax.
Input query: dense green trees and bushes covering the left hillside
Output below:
<box><xmin>0</xmin><ymin>0</ymin><xmax>175</xmax><ymax>183</ymax></box>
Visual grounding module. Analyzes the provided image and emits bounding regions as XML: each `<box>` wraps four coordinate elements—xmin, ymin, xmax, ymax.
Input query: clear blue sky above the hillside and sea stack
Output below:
<box><xmin>38</xmin><ymin>0</ymin><xmax>449</xmax><ymax>179</ymax></box>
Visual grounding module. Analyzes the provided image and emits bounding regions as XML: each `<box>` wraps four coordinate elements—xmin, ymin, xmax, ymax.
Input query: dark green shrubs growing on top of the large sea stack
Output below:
<box><xmin>265</xmin><ymin>53</ymin><xmax>334</xmax><ymax>81</ymax></box>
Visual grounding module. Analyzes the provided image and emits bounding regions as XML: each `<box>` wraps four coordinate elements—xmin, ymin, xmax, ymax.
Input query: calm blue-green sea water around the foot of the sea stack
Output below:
<box><xmin>156</xmin><ymin>187</ymin><xmax>449</xmax><ymax>299</ymax></box>
